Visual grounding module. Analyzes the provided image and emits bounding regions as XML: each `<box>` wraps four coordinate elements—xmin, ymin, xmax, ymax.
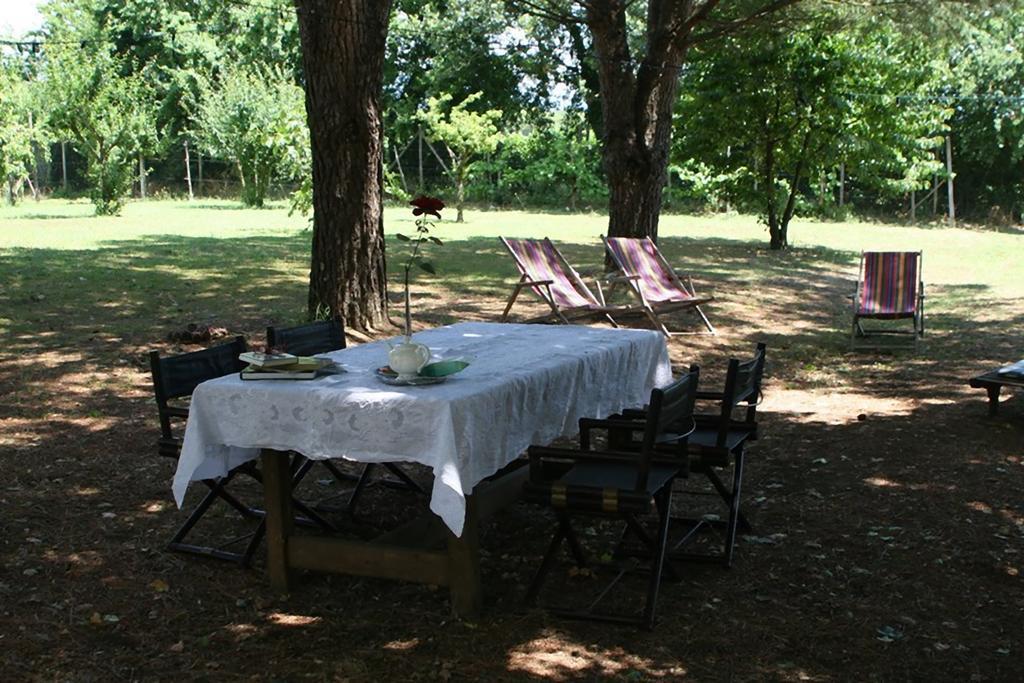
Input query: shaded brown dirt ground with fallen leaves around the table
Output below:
<box><xmin>0</xmin><ymin>242</ymin><xmax>1024</xmax><ymax>681</ymax></box>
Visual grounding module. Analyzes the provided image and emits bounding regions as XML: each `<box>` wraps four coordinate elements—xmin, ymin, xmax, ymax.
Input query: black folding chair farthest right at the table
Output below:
<box><xmin>608</xmin><ymin>343</ymin><xmax>766</xmax><ymax>567</ymax></box>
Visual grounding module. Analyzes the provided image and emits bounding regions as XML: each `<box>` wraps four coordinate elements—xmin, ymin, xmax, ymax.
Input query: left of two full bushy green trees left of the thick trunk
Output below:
<box><xmin>45</xmin><ymin>45</ymin><xmax>159</xmax><ymax>215</ymax></box>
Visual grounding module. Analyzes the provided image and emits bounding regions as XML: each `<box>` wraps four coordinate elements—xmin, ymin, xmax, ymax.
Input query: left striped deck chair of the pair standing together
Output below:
<box><xmin>499</xmin><ymin>238</ymin><xmax>621</xmax><ymax>327</ymax></box>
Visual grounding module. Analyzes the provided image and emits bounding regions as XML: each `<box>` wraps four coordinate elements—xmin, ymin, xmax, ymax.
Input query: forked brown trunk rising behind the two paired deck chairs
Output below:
<box><xmin>587</xmin><ymin>0</ymin><xmax>693</xmax><ymax>239</ymax></box>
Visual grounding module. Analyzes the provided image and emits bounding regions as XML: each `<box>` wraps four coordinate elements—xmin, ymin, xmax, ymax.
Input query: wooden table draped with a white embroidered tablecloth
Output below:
<box><xmin>174</xmin><ymin>323</ymin><xmax>672</xmax><ymax>614</ymax></box>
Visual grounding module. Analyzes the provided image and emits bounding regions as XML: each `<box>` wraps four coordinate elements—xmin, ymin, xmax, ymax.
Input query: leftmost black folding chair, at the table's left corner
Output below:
<box><xmin>150</xmin><ymin>337</ymin><xmax>333</xmax><ymax>566</ymax></box>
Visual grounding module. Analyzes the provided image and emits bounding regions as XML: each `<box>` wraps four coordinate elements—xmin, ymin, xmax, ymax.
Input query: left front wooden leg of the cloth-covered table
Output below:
<box><xmin>260</xmin><ymin>449</ymin><xmax>295</xmax><ymax>592</ymax></box>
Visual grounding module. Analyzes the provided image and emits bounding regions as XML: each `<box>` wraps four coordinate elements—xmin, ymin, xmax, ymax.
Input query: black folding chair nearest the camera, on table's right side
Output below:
<box><xmin>524</xmin><ymin>366</ymin><xmax>699</xmax><ymax>629</ymax></box>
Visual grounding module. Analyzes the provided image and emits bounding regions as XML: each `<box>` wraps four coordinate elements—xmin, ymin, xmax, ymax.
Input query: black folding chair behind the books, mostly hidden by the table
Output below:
<box><xmin>266</xmin><ymin>321</ymin><xmax>426</xmax><ymax>514</ymax></box>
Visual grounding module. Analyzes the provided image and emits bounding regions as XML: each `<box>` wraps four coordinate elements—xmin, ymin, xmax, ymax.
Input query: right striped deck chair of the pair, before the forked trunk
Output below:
<box><xmin>601</xmin><ymin>237</ymin><xmax>715</xmax><ymax>337</ymax></box>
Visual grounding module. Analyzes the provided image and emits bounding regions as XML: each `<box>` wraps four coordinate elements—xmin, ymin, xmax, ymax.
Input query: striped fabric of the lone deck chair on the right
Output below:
<box><xmin>857</xmin><ymin>252</ymin><xmax>921</xmax><ymax>317</ymax></box>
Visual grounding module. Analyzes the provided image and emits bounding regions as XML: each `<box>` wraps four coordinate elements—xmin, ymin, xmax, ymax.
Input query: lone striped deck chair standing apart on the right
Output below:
<box><xmin>850</xmin><ymin>252</ymin><xmax>925</xmax><ymax>350</ymax></box>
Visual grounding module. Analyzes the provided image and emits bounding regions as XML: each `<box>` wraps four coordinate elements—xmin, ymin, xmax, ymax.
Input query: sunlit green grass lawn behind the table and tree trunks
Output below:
<box><xmin>0</xmin><ymin>200</ymin><xmax>1024</xmax><ymax>366</ymax></box>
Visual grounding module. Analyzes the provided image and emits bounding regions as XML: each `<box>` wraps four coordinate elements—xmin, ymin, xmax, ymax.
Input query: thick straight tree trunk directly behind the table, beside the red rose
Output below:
<box><xmin>295</xmin><ymin>0</ymin><xmax>391</xmax><ymax>330</ymax></box>
